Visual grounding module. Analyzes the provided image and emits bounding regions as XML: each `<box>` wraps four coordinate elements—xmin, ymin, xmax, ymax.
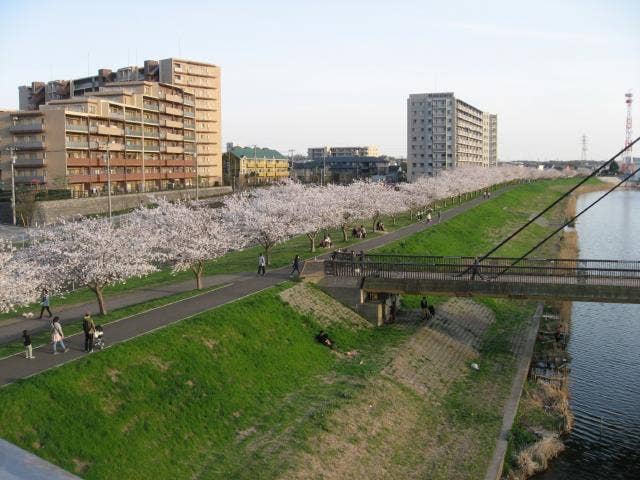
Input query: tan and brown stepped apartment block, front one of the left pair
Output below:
<box><xmin>0</xmin><ymin>81</ymin><xmax>199</xmax><ymax>197</ymax></box>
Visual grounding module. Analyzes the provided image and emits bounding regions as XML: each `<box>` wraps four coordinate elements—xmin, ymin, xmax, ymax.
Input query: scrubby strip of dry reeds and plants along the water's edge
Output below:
<box><xmin>503</xmin><ymin>182</ymin><xmax>610</xmax><ymax>480</ymax></box>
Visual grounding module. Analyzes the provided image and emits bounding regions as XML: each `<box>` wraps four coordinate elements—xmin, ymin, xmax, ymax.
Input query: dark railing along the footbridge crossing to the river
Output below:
<box><xmin>325</xmin><ymin>252</ymin><xmax>640</xmax><ymax>286</ymax></box>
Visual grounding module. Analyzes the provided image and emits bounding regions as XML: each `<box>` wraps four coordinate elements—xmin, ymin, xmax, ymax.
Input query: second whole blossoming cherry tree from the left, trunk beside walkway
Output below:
<box><xmin>132</xmin><ymin>200</ymin><xmax>244</xmax><ymax>290</ymax></box>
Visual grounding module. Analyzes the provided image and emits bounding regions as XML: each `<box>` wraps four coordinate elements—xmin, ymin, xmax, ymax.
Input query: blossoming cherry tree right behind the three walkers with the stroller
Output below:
<box><xmin>33</xmin><ymin>218</ymin><xmax>157</xmax><ymax>315</ymax></box>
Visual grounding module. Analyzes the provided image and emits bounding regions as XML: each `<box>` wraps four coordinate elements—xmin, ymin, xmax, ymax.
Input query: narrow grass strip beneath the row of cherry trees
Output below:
<box><xmin>0</xmin><ymin>187</ymin><xmax>498</xmax><ymax>323</ymax></box>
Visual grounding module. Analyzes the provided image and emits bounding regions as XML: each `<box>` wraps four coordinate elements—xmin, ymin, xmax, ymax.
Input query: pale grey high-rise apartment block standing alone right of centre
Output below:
<box><xmin>407</xmin><ymin>92</ymin><xmax>497</xmax><ymax>181</ymax></box>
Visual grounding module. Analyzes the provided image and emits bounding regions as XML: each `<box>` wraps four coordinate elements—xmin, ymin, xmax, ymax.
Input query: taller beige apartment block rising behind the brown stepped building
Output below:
<box><xmin>18</xmin><ymin>58</ymin><xmax>222</xmax><ymax>186</ymax></box>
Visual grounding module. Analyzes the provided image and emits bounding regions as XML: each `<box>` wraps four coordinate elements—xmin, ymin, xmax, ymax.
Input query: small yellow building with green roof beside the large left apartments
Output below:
<box><xmin>222</xmin><ymin>147</ymin><xmax>289</xmax><ymax>187</ymax></box>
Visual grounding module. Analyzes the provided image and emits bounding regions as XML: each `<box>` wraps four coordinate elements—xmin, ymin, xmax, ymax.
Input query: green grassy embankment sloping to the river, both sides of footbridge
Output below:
<box><xmin>0</xmin><ymin>181</ymin><xmax>584</xmax><ymax>479</ymax></box>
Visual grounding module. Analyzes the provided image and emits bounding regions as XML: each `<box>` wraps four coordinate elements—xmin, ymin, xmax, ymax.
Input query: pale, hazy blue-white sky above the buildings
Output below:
<box><xmin>0</xmin><ymin>0</ymin><xmax>640</xmax><ymax>161</ymax></box>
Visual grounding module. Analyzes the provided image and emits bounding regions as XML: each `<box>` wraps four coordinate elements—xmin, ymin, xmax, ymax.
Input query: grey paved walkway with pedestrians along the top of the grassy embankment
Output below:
<box><xmin>0</xmin><ymin>189</ymin><xmax>506</xmax><ymax>387</ymax></box>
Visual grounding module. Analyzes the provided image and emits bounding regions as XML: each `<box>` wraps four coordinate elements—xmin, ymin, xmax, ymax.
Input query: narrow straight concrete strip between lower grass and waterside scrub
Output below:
<box><xmin>484</xmin><ymin>303</ymin><xmax>544</xmax><ymax>480</ymax></box>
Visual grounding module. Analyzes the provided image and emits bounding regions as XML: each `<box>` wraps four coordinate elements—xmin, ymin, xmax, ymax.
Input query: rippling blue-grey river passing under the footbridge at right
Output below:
<box><xmin>536</xmin><ymin>190</ymin><xmax>640</xmax><ymax>480</ymax></box>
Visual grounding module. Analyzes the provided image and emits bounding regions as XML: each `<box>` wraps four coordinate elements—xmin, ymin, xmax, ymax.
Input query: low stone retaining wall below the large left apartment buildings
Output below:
<box><xmin>30</xmin><ymin>187</ymin><xmax>232</xmax><ymax>225</ymax></box>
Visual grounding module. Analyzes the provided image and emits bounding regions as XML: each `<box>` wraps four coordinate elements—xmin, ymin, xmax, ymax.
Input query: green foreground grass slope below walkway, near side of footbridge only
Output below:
<box><xmin>0</xmin><ymin>288</ymin><xmax>410</xmax><ymax>479</ymax></box>
